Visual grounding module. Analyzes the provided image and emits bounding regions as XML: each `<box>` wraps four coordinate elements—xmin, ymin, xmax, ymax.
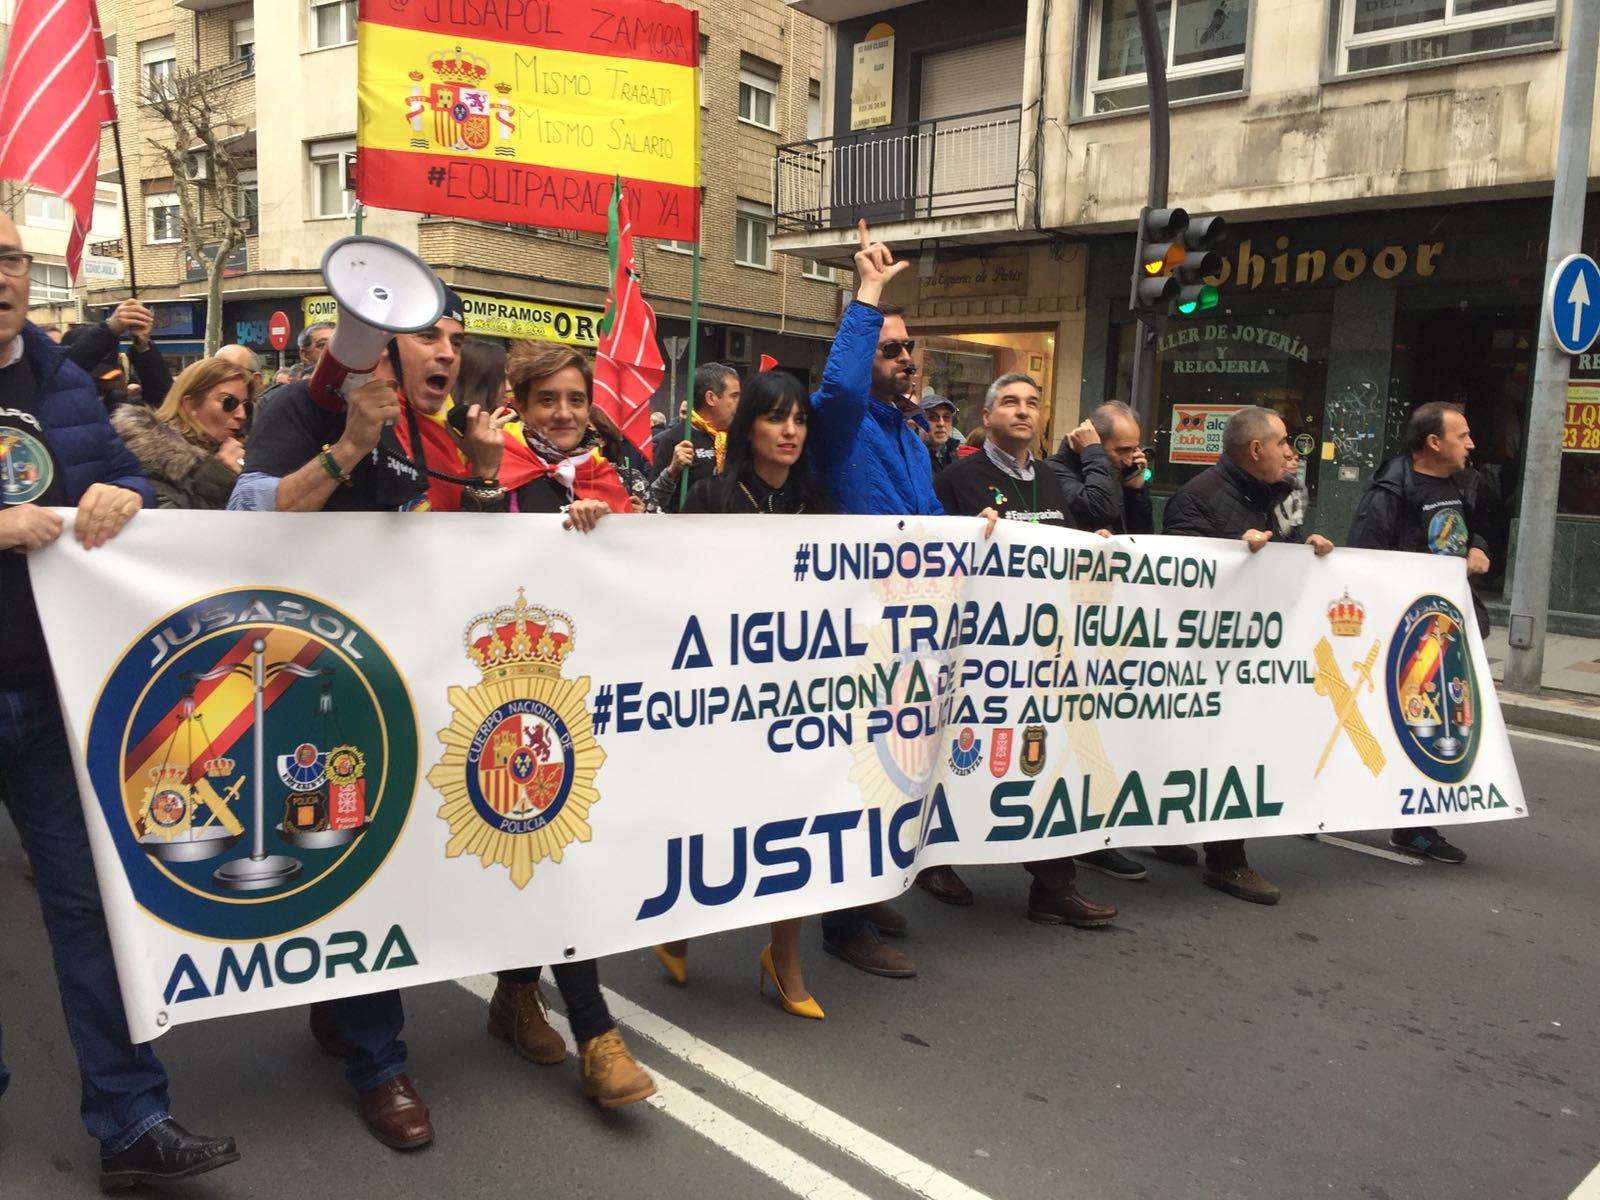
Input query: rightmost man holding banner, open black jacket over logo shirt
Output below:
<box><xmin>1350</xmin><ymin>402</ymin><xmax>1490</xmax><ymax>862</ymax></box>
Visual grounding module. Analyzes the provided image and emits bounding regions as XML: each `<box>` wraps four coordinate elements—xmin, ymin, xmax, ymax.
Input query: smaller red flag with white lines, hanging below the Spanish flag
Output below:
<box><xmin>595</xmin><ymin>178</ymin><xmax>667</xmax><ymax>458</ymax></box>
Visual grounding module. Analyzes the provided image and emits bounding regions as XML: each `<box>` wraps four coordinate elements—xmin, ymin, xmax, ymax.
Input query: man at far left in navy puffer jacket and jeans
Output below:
<box><xmin>0</xmin><ymin>213</ymin><xmax>238</xmax><ymax>1187</ymax></box>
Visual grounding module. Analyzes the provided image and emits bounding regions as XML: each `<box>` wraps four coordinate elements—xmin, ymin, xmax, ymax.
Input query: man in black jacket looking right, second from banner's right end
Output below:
<box><xmin>1162</xmin><ymin>405</ymin><xmax>1333</xmax><ymax>904</ymax></box>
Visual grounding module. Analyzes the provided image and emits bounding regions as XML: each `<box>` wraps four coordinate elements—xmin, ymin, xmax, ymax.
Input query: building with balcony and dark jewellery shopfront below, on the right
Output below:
<box><xmin>774</xmin><ymin>0</ymin><xmax>1600</xmax><ymax>614</ymax></box>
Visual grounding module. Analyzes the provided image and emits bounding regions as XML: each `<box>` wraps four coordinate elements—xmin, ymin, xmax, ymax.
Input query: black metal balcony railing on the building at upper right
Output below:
<box><xmin>774</xmin><ymin>106</ymin><xmax>1022</xmax><ymax>232</ymax></box>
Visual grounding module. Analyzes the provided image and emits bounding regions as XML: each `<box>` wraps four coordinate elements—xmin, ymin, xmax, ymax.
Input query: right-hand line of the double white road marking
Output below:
<box><xmin>603</xmin><ymin>987</ymin><xmax>984</xmax><ymax>1200</ymax></box>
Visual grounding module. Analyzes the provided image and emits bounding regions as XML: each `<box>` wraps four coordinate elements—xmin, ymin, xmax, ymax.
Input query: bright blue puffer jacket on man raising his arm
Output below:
<box><xmin>806</xmin><ymin>301</ymin><xmax>944</xmax><ymax>517</ymax></box>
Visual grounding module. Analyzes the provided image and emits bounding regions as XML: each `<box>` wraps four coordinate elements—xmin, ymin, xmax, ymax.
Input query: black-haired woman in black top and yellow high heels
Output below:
<box><xmin>656</xmin><ymin>371</ymin><xmax>834</xmax><ymax>1021</ymax></box>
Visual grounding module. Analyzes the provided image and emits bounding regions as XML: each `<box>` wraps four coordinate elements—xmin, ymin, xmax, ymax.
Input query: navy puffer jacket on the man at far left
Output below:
<box><xmin>22</xmin><ymin>322</ymin><xmax>155</xmax><ymax>509</ymax></box>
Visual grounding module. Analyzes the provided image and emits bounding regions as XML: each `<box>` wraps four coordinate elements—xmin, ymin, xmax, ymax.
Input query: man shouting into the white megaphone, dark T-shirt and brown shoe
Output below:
<box><xmin>229</xmin><ymin>288</ymin><xmax>502</xmax><ymax>1150</ymax></box>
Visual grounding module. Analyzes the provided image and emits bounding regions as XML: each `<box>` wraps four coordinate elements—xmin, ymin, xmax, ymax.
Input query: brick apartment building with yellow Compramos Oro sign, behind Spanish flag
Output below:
<box><xmin>65</xmin><ymin>0</ymin><xmax>840</xmax><ymax>408</ymax></box>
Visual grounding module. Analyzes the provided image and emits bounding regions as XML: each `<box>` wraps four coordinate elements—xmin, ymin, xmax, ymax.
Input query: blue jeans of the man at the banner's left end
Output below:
<box><xmin>0</xmin><ymin>683</ymin><xmax>168</xmax><ymax>1154</ymax></box>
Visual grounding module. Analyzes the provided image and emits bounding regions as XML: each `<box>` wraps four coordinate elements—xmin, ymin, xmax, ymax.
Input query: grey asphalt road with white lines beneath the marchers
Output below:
<box><xmin>0</xmin><ymin>736</ymin><xmax>1600</xmax><ymax>1200</ymax></box>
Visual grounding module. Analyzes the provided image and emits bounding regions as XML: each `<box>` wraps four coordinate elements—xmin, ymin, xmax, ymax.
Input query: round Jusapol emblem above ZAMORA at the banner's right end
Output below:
<box><xmin>1387</xmin><ymin>595</ymin><xmax>1482</xmax><ymax>784</ymax></box>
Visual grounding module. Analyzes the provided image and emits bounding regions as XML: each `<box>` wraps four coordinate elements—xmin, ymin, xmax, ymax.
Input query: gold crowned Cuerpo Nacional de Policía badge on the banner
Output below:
<box><xmin>427</xmin><ymin>589</ymin><xmax>605</xmax><ymax>888</ymax></box>
